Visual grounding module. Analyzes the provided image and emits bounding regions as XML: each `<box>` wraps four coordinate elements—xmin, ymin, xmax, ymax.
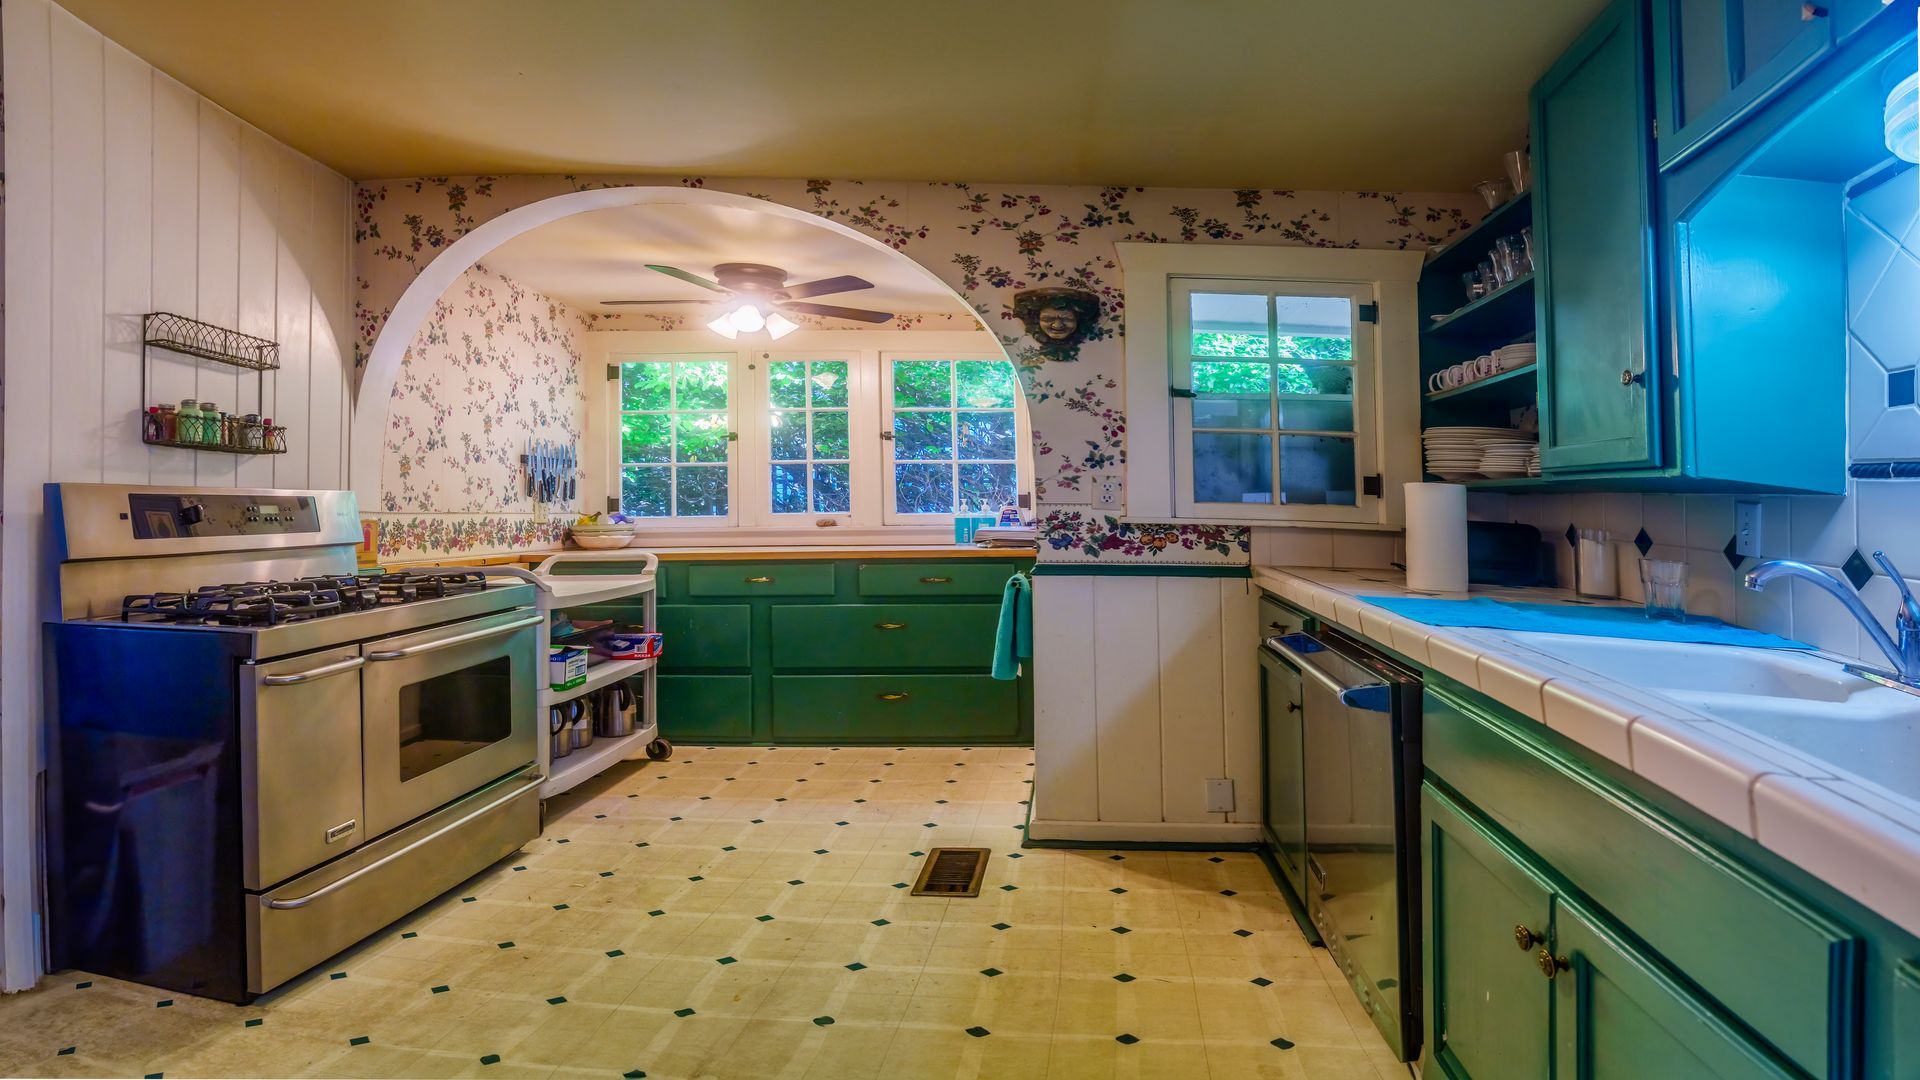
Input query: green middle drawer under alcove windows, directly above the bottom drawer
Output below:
<box><xmin>774</xmin><ymin>603</ymin><xmax>1000</xmax><ymax>671</ymax></box>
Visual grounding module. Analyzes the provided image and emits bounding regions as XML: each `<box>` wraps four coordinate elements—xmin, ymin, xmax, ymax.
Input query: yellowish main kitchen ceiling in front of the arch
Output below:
<box><xmin>60</xmin><ymin>0</ymin><xmax>1605</xmax><ymax>190</ymax></box>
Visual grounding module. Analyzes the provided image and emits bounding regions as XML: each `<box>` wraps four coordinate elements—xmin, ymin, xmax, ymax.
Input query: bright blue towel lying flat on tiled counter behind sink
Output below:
<box><xmin>1361</xmin><ymin>596</ymin><xmax>1812</xmax><ymax>650</ymax></box>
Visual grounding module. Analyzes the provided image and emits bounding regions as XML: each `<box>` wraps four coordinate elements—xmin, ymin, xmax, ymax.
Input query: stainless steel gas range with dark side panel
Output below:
<box><xmin>46</xmin><ymin>484</ymin><xmax>541</xmax><ymax>1001</ymax></box>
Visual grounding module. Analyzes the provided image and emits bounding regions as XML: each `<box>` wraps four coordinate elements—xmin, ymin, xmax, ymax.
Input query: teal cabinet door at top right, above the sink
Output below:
<box><xmin>1653</xmin><ymin>0</ymin><xmax>1834</xmax><ymax>167</ymax></box>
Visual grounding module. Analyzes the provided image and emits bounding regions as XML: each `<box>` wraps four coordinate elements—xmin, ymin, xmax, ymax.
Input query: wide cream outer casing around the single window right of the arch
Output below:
<box><xmin>1116</xmin><ymin>242</ymin><xmax>1425</xmax><ymax>528</ymax></box>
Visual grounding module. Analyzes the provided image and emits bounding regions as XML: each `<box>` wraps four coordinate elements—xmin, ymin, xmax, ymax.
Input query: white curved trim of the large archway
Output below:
<box><xmin>349</xmin><ymin>186</ymin><xmax>1004</xmax><ymax>509</ymax></box>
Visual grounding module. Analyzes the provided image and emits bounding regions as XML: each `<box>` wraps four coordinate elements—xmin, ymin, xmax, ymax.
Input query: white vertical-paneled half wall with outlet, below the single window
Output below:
<box><xmin>1031</xmin><ymin>575</ymin><xmax>1261</xmax><ymax>844</ymax></box>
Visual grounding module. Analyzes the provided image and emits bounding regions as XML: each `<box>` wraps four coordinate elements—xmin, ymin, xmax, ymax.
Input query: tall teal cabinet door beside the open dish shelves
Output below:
<box><xmin>1532</xmin><ymin>0</ymin><xmax>1661</xmax><ymax>473</ymax></box>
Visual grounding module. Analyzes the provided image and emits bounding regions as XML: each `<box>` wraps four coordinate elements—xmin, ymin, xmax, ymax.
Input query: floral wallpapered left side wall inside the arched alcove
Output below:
<box><xmin>369</xmin><ymin>265</ymin><xmax>589</xmax><ymax>559</ymax></box>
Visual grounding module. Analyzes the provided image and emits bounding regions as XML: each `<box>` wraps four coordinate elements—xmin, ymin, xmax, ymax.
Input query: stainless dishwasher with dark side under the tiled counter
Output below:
<box><xmin>1260</xmin><ymin>628</ymin><xmax>1421</xmax><ymax>1061</ymax></box>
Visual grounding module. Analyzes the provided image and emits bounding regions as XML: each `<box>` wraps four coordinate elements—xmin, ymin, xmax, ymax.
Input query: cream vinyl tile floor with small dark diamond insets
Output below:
<box><xmin>0</xmin><ymin>746</ymin><xmax>1407</xmax><ymax>1080</ymax></box>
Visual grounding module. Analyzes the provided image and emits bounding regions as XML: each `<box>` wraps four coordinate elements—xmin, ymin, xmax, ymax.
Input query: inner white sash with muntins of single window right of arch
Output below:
<box><xmin>1167</xmin><ymin>277</ymin><xmax>1380</xmax><ymax>525</ymax></box>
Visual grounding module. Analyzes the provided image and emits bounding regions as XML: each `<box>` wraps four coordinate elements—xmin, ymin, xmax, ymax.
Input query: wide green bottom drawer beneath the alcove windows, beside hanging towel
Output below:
<box><xmin>774</xmin><ymin>675</ymin><xmax>1020</xmax><ymax>742</ymax></box>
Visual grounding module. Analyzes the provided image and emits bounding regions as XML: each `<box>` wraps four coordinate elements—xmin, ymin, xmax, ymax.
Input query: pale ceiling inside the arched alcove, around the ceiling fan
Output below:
<box><xmin>472</xmin><ymin>204</ymin><xmax>968</xmax><ymax>315</ymax></box>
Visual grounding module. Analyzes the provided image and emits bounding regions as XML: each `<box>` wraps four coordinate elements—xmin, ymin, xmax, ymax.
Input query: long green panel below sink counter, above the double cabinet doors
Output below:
<box><xmin>1425</xmin><ymin>682</ymin><xmax>1864</xmax><ymax>1076</ymax></box>
